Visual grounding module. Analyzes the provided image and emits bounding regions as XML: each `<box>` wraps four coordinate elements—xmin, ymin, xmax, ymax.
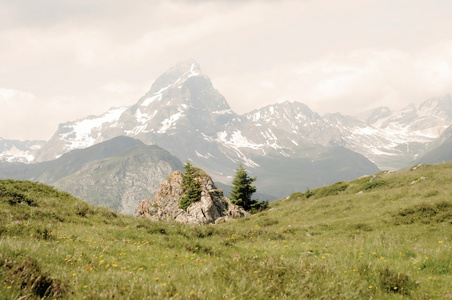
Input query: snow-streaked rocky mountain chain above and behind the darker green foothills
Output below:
<box><xmin>8</xmin><ymin>60</ymin><xmax>452</xmax><ymax>175</ymax></box>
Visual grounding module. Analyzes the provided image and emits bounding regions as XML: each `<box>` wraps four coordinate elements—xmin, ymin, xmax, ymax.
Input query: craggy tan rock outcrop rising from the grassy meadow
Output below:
<box><xmin>136</xmin><ymin>169</ymin><xmax>249</xmax><ymax>224</ymax></box>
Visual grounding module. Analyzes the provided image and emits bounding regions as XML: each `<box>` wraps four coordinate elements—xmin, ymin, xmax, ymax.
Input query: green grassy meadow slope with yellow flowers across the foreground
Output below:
<box><xmin>0</xmin><ymin>164</ymin><xmax>452</xmax><ymax>299</ymax></box>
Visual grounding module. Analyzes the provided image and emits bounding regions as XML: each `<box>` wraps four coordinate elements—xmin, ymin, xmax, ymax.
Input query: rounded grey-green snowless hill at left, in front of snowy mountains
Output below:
<box><xmin>0</xmin><ymin>136</ymin><xmax>182</xmax><ymax>215</ymax></box>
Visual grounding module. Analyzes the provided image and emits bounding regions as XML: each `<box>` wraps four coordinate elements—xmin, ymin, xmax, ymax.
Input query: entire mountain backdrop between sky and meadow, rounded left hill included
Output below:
<box><xmin>0</xmin><ymin>60</ymin><xmax>452</xmax><ymax>214</ymax></box>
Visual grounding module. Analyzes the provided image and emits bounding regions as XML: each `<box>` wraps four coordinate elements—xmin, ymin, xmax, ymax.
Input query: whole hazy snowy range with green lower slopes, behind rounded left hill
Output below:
<box><xmin>0</xmin><ymin>60</ymin><xmax>452</xmax><ymax>211</ymax></box>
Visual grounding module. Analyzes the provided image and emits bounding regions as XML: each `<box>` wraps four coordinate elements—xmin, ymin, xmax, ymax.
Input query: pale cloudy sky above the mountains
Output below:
<box><xmin>0</xmin><ymin>0</ymin><xmax>452</xmax><ymax>139</ymax></box>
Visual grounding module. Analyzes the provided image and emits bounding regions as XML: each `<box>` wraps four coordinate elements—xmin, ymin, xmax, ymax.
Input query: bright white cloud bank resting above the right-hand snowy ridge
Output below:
<box><xmin>220</xmin><ymin>41</ymin><xmax>452</xmax><ymax>114</ymax></box>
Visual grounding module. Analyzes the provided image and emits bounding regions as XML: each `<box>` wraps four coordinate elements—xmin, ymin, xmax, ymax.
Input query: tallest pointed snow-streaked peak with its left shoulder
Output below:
<box><xmin>36</xmin><ymin>60</ymin><xmax>236</xmax><ymax>162</ymax></box>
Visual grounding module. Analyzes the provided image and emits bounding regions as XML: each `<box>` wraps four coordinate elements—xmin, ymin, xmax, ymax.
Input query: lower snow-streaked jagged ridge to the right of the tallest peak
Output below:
<box><xmin>245</xmin><ymin>95</ymin><xmax>452</xmax><ymax>170</ymax></box>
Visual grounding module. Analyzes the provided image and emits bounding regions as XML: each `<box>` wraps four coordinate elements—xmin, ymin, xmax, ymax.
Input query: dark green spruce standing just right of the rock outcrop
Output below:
<box><xmin>230</xmin><ymin>163</ymin><xmax>268</xmax><ymax>212</ymax></box>
